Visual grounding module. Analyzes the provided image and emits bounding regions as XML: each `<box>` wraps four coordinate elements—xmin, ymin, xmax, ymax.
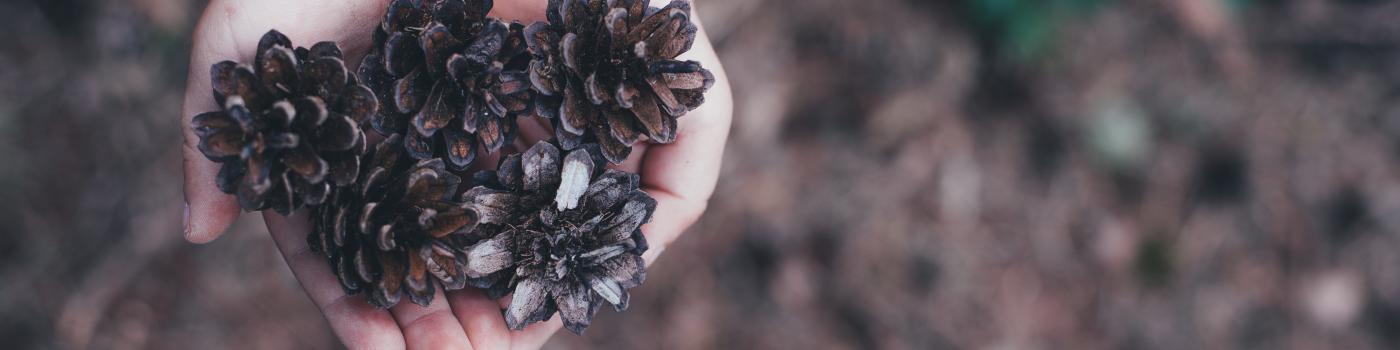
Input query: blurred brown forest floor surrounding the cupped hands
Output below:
<box><xmin>0</xmin><ymin>0</ymin><xmax>1400</xmax><ymax>349</ymax></box>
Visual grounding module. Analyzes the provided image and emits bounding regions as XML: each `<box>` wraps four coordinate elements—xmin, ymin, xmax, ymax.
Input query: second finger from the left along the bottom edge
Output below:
<box><xmin>389</xmin><ymin>287</ymin><xmax>472</xmax><ymax>350</ymax></box>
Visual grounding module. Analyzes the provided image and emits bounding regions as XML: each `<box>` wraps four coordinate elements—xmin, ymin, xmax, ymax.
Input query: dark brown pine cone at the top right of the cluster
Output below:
<box><xmin>525</xmin><ymin>0</ymin><xmax>714</xmax><ymax>162</ymax></box>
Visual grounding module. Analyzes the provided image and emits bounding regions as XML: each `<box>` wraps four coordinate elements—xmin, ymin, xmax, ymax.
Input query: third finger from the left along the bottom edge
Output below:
<box><xmin>447</xmin><ymin>288</ymin><xmax>511</xmax><ymax>350</ymax></box>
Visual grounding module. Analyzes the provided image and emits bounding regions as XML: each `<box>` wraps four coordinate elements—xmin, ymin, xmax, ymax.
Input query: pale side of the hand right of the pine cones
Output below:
<box><xmin>641</xmin><ymin>18</ymin><xmax>734</xmax><ymax>263</ymax></box>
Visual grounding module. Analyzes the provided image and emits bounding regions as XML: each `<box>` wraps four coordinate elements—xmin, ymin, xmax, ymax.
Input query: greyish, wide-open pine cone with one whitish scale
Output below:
<box><xmin>463</xmin><ymin>143</ymin><xmax>657</xmax><ymax>333</ymax></box>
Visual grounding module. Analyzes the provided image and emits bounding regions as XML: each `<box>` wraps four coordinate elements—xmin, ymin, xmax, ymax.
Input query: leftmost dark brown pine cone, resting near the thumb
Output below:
<box><xmin>190</xmin><ymin>31</ymin><xmax>378</xmax><ymax>214</ymax></box>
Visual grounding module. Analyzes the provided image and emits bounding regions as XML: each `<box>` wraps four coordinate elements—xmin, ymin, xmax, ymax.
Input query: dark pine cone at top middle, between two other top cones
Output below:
<box><xmin>360</xmin><ymin>0</ymin><xmax>533</xmax><ymax>169</ymax></box>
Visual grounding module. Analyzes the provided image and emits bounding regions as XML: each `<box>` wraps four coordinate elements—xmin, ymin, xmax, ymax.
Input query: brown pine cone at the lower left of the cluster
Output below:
<box><xmin>307</xmin><ymin>134</ymin><xmax>476</xmax><ymax>308</ymax></box>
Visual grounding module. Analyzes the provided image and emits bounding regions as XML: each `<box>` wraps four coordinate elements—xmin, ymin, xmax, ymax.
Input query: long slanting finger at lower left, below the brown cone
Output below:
<box><xmin>263</xmin><ymin>211</ymin><xmax>405</xmax><ymax>349</ymax></box>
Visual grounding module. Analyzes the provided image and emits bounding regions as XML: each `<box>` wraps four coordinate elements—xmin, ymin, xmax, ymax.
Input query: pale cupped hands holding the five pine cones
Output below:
<box><xmin>181</xmin><ymin>0</ymin><xmax>732</xmax><ymax>349</ymax></box>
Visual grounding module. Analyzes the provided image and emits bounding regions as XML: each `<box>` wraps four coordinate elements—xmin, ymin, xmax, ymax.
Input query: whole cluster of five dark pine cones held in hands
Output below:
<box><xmin>190</xmin><ymin>0</ymin><xmax>714</xmax><ymax>333</ymax></box>
